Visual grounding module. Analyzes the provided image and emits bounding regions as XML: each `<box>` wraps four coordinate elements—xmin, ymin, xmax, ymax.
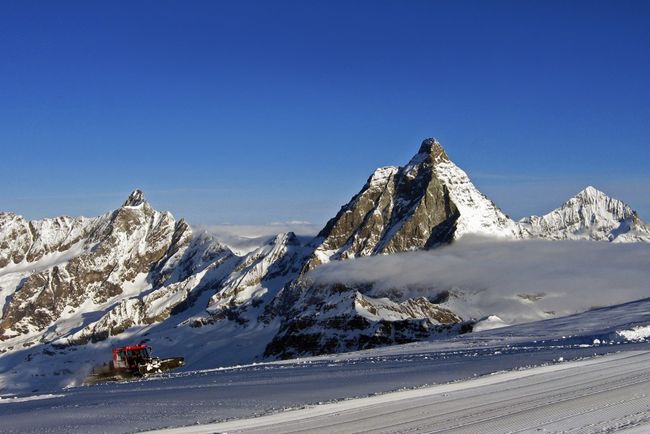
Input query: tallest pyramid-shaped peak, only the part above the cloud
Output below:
<box><xmin>305</xmin><ymin>139</ymin><xmax>519</xmax><ymax>271</ymax></box>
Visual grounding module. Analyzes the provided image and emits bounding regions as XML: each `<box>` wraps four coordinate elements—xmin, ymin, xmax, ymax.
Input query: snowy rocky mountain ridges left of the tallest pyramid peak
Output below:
<box><xmin>0</xmin><ymin>190</ymin><xmax>300</xmax><ymax>351</ymax></box>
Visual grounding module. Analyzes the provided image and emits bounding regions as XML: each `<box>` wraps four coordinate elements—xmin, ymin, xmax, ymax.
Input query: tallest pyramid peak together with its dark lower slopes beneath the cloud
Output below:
<box><xmin>266</xmin><ymin>139</ymin><xmax>519</xmax><ymax>358</ymax></box>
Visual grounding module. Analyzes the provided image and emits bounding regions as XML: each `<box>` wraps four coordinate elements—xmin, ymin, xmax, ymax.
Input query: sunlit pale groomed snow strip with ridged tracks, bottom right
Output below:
<box><xmin>153</xmin><ymin>351</ymin><xmax>650</xmax><ymax>434</ymax></box>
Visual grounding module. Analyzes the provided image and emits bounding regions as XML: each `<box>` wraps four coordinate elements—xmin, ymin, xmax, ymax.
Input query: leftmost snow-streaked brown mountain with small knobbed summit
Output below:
<box><xmin>0</xmin><ymin>190</ymin><xmax>184</xmax><ymax>345</ymax></box>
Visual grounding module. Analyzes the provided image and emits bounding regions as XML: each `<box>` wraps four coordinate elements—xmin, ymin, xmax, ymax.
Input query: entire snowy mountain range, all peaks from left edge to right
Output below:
<box><xmin>0</xmin><ymin>139</ymin><xmax>650</xmax><ymax>394</ymax></box>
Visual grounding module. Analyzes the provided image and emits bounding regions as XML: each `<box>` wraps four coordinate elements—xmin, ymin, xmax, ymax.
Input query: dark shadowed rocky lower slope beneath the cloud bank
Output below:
<box><xmin>265</xmin><ymin>284</ymin><xmax>472</xmax><ymax>359</ymax></box>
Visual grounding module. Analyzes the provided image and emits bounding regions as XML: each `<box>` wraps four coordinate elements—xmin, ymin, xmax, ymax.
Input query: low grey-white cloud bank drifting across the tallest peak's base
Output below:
<box><xmin>309</xmin><ymin>238</ymin><xmax>650</xmax><ymax>323</ymax></box>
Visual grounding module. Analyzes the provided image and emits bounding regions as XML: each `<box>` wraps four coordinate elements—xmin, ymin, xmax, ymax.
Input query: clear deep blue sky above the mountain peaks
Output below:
<box><xmin>0</xmin><ymin>0</ymin><xmax>650</xmax><ymax>224</ymax></box>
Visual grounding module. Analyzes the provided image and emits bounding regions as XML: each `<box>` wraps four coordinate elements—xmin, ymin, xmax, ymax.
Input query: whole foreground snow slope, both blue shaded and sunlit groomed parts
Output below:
<box><xmin>0</xmin><ymin>299</ymin><xmax>650</xmax><ymax>433</ymax></box>
